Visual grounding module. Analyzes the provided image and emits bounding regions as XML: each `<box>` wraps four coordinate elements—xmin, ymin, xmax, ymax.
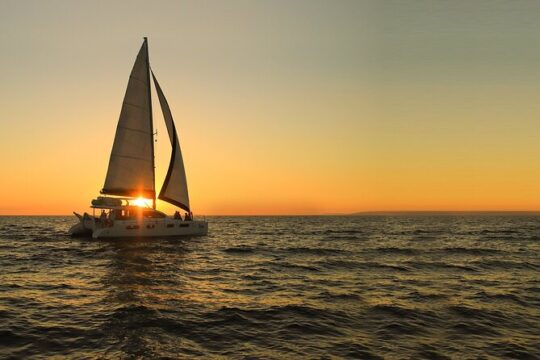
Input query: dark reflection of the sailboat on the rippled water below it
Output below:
<box><xmin>102</xmin><ymin>239</ymin><xmax>193</xmax><ymax>357</ymax></box>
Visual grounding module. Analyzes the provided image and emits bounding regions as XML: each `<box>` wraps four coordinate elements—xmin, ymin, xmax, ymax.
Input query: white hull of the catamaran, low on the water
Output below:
<box><xmin>70</xmin><ymin>218</ymin><xmax>208</xmax><ymax>239</ymax></box>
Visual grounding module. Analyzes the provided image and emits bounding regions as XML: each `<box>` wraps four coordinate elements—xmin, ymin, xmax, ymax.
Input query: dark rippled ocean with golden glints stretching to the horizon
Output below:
<box><xmin>0</xmin><ymin>214</ymin><xmax>540</xmax><ymax>359</ymax></box>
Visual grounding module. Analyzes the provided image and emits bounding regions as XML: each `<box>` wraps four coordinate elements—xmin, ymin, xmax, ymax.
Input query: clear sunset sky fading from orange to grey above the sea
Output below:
<box><xmin>0</xmin><ymin>0</ymin><xmax>540</xmax><ymax>214</ymax></box>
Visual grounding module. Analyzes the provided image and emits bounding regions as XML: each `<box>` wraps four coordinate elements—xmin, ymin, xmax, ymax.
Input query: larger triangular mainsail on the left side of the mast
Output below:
<box><xmin>101</xmin><ymin>38</ymin><xmax>155</xmax><ymax>198</ymax></box>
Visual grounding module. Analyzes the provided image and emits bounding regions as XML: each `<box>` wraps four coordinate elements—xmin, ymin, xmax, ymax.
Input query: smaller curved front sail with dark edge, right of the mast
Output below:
<box><xmin>152</xmin><ymin>72</ymin><xmax>190</xmax><ymax>211</ymax></box>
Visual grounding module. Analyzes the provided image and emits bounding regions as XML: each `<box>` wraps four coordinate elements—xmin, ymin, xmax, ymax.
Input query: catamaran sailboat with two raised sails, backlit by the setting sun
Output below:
<box><xmin>69</xmin><ymin>37</ymin><xmax>208</xmax><ymax>239</ymax></box>
